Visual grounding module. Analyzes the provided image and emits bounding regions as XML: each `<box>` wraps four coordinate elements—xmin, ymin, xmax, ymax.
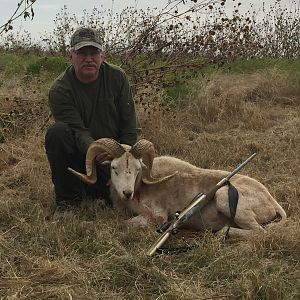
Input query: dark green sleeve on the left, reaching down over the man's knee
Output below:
<box><xmin>48</xmin><ymin>85</ymin><xmax>94</xmax><ymax>155</ymax></box>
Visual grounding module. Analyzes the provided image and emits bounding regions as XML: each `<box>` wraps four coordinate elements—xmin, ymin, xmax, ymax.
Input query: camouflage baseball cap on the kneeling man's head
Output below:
<box><xmin>71</xmin><ymin>28</ymin><xmax>103</xmax><ymax>51</ymax></box>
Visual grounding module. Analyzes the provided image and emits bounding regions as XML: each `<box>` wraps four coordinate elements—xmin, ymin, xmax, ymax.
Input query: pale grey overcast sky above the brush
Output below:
<box><xmin>0</xmin><ymin>0</ymin><xmax>300</xmax><ymax>39</ymax></box>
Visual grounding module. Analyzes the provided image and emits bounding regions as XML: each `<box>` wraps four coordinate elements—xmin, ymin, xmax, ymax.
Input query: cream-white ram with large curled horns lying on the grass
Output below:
<box><xmin>69</xmin><ymin>138</ymin><xmax>286</xmax><ymax>237</ymax></box>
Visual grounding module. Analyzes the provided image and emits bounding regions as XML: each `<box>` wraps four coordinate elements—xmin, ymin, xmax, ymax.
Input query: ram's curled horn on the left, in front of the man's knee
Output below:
<box><xmin>68</xmin><ymin>138</ymin><xmax>125</xmax><ymax>184</ymax></box>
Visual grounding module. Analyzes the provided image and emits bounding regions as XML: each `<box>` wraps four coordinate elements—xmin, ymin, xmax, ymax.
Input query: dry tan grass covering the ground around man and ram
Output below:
<box><xmin>0</xmin><ymin>71</ymin><xmax>300</xmax><ymax>300</ymax></box>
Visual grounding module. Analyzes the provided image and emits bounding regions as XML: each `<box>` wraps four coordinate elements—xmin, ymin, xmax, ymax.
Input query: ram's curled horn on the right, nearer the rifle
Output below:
<box><xmin>129</xmin><ymin>139</ymin><xmax>177</xmax><ymax>184</ymax></box>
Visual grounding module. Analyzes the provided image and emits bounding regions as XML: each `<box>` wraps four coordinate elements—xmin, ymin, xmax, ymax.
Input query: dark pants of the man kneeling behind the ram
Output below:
<box><xmin>45</xmin><ymin>122</ymin><xmax>111</xmax><ymax>205</ymax></box>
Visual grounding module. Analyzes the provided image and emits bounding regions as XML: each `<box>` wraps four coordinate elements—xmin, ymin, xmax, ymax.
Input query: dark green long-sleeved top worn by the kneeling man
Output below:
<box><xmin>48</xmin><ymin>62</ymin><xmax>139</xmax><ymax>154</ymax></box>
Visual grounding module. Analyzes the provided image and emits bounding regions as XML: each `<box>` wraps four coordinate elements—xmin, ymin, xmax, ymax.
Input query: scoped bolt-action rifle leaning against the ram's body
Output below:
<box><xmin>146</xmin><ymin>153</ymin><xmax>256</xmax><ymax>256</ymax></box>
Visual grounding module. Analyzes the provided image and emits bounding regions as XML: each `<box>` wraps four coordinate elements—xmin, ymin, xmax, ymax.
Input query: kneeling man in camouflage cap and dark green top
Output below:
<box><xmin>45</xmin><ymin>28</ymin><xmax>138</xmax><ymax>211</ymax></box>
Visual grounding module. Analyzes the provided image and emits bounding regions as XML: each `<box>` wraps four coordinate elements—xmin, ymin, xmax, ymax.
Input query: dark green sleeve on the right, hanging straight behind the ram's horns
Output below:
<box><xmin>117</xmin><ymin>72</ymin><xmax>141</xmax><ymax>145</ymax></box>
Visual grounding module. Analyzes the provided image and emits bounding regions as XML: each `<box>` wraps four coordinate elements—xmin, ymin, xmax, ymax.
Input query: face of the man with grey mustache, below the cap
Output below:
<box><xmin>71</xmin><ymin>46</ymin><xmax>104</xmax><ymax>83</ymax></box>
